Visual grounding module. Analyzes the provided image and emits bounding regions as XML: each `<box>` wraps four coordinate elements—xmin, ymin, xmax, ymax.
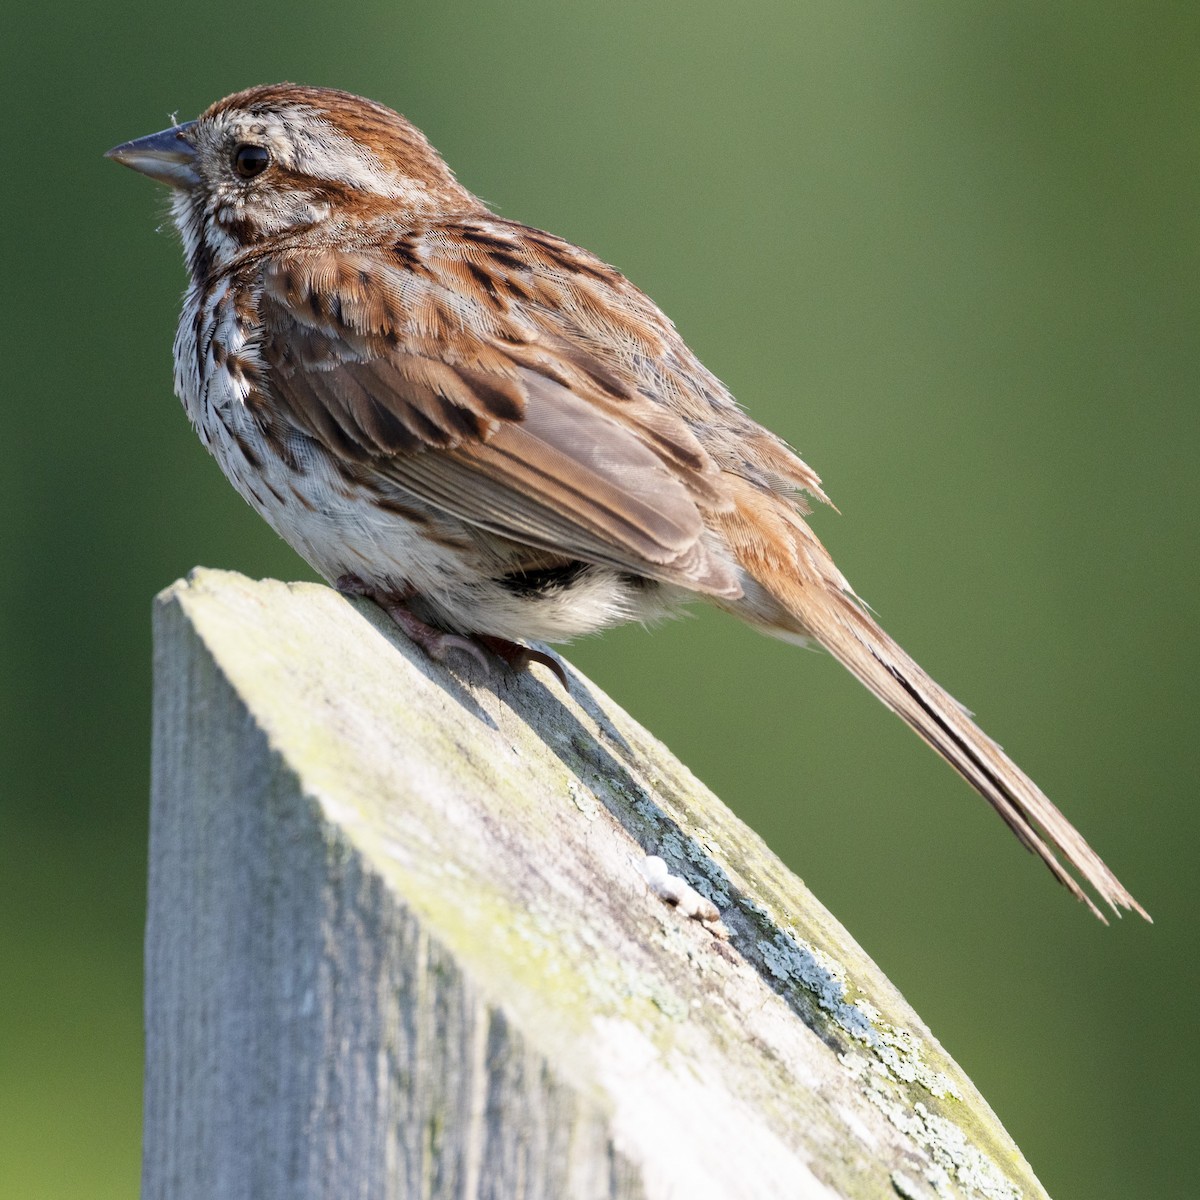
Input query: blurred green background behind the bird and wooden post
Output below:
<box><xmin>0</xmin><ymin>0</ymin><xmax>1200</xmax><ymax>1200</ymax></box>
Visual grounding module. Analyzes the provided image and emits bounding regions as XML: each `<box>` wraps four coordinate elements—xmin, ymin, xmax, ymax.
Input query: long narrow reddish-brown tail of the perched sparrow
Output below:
<box><xmin>715</xmin><ymin>492</ymin><xmax>1151</xmax><ymax>920</ymax></box>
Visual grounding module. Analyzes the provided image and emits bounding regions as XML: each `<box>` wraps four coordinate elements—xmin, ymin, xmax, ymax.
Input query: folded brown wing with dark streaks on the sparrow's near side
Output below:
<box><xmin>260</xmin><ymin>251</ymin><xmax>740</xmax><ymax>598</ymax></box>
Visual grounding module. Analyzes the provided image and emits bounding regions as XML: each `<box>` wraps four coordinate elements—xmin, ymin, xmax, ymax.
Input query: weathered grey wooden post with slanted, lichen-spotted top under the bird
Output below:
<box><xmin>143</xmin><ymin>570</ymin><xmax>1044</xmax><ymax>1200</ymax></box>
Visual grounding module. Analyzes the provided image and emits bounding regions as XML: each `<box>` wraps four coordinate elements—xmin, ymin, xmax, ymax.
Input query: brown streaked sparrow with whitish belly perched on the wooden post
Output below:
<box><xmin>109</xmin><ymin>84</ymin><xmax>1146</xmax><ymax>916</ymax></box>
